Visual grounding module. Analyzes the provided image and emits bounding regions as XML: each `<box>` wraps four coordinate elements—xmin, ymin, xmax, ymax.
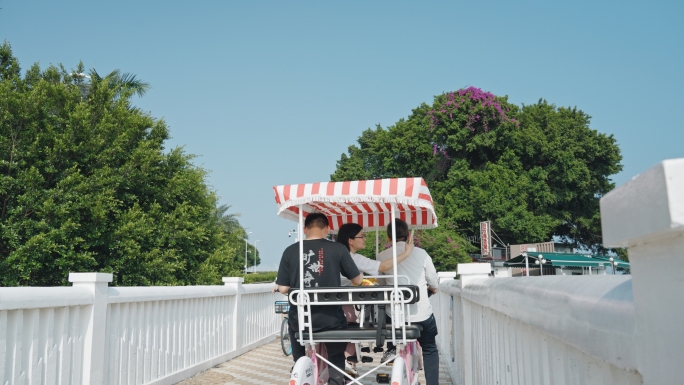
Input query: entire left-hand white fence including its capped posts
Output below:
<box><xmin>0</xmin><ymin>273</ymin><xmax>282</xmax><ymax>385</ymax></box>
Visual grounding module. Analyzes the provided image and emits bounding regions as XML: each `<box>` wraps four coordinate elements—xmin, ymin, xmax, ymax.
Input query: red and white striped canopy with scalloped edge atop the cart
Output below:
<box><xmin>273</xmin><ymin>178</ymin><xmax>437</xmax><ymax>233</ymax></box>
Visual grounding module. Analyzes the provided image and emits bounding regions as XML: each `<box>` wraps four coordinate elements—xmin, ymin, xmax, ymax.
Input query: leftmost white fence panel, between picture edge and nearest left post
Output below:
<box><xmin>0</xmin><ymin>287</ymin><xmax>93</xmax><ymax>385</ymax></box>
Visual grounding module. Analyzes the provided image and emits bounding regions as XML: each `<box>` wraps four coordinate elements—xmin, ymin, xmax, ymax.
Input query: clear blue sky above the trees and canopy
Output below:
<box><xmin>0</xmin><ymin>0</ymin><xmax>684</xmax><ymax>270</ymax></box>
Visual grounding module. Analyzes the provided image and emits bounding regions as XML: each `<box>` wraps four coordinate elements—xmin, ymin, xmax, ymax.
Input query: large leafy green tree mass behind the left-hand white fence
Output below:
<box><xmin>0</xmin><ymin>43</ymin><xmax>244</xmax><ymax>286</ymax></box>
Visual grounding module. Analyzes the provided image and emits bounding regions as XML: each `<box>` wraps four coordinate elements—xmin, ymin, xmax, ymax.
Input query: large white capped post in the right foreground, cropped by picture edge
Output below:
<box><xmin>601</xmin><ymin>158</ymin><xmax>684</xmax><ymax>385</ymax></box>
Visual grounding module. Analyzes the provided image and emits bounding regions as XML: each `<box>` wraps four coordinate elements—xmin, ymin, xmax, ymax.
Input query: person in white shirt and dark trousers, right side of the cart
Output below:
<box><xmin>378</xmin><ymin>219</ymin><xmax>439</xmax><ymax>385</ymax></box>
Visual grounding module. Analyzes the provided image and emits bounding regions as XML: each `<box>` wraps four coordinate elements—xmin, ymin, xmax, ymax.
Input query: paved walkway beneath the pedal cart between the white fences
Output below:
<box><xmin>177</xmin><ymin>339</ymin><xmax>452</xmax><ymax>385</ymax></box>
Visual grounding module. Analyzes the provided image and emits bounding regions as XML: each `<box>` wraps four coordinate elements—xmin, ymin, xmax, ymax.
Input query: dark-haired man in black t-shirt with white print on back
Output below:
<box><xmin>276</xmin><ymin>213</ymin><xmax>363</xmax><ymax>385</ymax></box>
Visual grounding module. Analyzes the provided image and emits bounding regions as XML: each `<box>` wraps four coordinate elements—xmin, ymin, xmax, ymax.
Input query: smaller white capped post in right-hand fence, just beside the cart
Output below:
<box><xmin>454</xmin><ymin>262</ymin><xmax>492</xmax><ymax>385</ymax></box>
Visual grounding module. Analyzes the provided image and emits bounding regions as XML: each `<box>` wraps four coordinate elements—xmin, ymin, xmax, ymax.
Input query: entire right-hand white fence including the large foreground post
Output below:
<box><xmin>431</xmin><ymin>159</ymin><xmax>684</xmax><ymax>385</ymax></box>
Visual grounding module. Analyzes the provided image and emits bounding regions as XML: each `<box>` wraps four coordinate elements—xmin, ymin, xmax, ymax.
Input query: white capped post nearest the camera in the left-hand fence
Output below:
<box><xmin>69</xmin><ymin>273</ymin><xmax>113</xmax><ymax>385</ymax></box>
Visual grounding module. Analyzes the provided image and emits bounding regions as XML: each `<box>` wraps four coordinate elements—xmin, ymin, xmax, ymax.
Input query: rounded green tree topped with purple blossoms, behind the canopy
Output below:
<box><xmin>331</xmin><ymin>87</ymin><xmax>622</xmax><ymax>251</ymax></box>
